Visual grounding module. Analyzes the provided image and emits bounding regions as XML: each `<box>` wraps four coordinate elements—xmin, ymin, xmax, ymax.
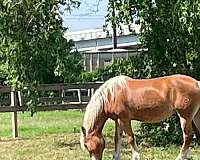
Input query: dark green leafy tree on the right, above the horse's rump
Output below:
<box><xmin>107</xmin><ymin>0</ymin><xmax>200</xmax><ymax>78</ymax></box>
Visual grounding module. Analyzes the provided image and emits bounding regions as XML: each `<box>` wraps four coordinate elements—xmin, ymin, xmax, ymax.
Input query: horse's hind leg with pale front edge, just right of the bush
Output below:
<box><xmin>176</xmin><ymin>114</ymin><xmax>192</xmax><ymax>160</ymax></box>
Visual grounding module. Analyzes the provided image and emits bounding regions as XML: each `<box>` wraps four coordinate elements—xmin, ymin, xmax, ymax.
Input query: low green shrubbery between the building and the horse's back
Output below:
<box><xmin>81</xmin><ymin>54</ymin><xmax>151</xmax><ymax>82</ymax></box>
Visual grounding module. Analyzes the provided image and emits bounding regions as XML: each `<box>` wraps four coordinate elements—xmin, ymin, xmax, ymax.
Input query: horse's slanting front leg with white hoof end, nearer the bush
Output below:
<box><xmin>120</xmin><ymin>121</ymin><xmax>140</xmax><ymax>160</ymax></box>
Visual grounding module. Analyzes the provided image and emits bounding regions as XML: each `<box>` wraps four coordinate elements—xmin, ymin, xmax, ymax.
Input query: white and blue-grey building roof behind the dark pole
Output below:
<box><xmin>64</xmin><ymin>24</ymin><xmax>141</xmax><ymax>52</ymax></box>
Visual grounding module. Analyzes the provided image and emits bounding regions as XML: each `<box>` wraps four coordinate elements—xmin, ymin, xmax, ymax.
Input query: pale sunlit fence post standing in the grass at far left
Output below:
<box><xmin>10</xmin><ymin>90</ymin><xmax>18</xmax><ymax>138</ymax></box>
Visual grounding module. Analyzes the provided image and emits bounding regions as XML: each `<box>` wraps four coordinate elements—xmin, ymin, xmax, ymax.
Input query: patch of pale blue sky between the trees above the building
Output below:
<box><xmin>62</xmin><ymin>0</ymin><xmax>107</xmax><ymax>31</ymax></box>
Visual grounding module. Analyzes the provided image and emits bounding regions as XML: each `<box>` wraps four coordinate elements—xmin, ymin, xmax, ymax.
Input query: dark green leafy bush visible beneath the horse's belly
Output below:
<box><xmin>137</xmin><ymin>114</ymin><xmax>183</xmax><ymax>146</ymax></box>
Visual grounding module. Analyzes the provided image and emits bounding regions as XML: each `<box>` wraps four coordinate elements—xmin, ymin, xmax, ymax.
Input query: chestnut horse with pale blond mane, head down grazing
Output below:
<box><xmin>80</xmin><ymin>75</ymin><xmax>200</xmax><ymax>160</ymax></box>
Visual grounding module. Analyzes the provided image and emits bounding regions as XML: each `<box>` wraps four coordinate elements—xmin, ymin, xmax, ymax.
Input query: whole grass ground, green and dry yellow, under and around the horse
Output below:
<box><xmin>0</xmin><ymin>111</ymin><xmax>200</xmax><ymax>160</ymax></box>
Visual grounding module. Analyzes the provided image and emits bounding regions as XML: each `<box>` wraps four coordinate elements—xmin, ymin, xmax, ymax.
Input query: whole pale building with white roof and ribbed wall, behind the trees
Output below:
<box><xmin>65</xmin><ymin>24</ymin><xmax>140</xmax><ymax>71</ymax></box>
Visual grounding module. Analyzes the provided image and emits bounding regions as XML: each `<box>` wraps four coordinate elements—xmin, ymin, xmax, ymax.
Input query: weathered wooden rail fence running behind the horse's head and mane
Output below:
<box><xmin>0</xmin><ymin>82</ymin><xmax>103</xmax><ymax>138</ymax></box>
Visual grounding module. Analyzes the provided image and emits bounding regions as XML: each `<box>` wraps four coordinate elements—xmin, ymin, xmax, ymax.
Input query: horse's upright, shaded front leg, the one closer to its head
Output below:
<box><xmin>113</xmin><ymin>119</ymin><xmax>123</xmax><ymax>160</ymax></box>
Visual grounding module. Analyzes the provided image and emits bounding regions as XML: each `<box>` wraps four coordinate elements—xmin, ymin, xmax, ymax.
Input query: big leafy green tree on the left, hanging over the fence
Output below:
<box><xmin>0</xmin><ymin>0</ymin><xmax>82</xmax><ymax>112</ymax></box>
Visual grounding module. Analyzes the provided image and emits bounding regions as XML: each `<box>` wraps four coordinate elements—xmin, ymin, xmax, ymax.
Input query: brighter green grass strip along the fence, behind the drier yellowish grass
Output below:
<box><xmin>0</xmin><ymin>111</ymin><xmax>83</xmax><ymax>138</ymax></box>
